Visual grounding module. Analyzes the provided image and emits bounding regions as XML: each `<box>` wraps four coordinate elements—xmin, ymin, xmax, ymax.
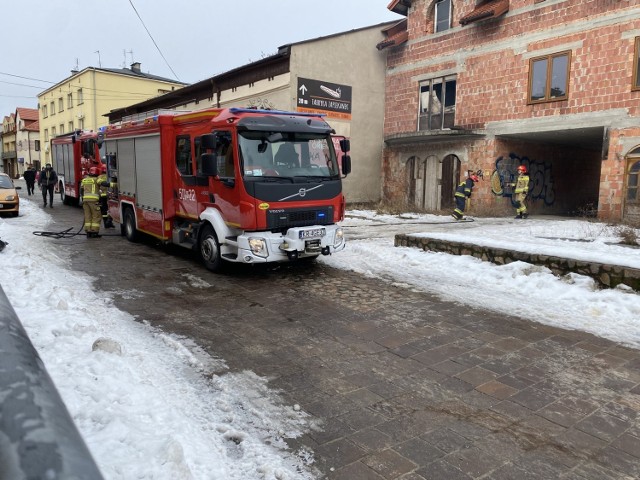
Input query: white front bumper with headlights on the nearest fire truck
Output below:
<box><xmin>237</xmin><ymin>225</ymin><xmax>346</xmax><ymax>263</ymax></box>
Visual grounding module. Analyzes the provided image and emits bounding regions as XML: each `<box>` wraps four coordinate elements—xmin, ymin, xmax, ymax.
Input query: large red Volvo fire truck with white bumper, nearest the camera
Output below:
<box><xmin>103</xmin><ymin>108</ymin><xmax>351</xmax><ymax>271</ymax></box>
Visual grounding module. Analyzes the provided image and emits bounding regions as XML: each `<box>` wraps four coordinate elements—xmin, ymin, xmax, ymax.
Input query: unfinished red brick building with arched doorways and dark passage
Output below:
<box><xmin>378</xmin><ymin>0</ymin><xmax>640</xmax><ymax>221</ymax></box>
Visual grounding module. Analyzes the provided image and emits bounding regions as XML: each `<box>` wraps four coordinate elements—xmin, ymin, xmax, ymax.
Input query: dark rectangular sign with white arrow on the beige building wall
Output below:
<box><xmin>297</xmin><ymin>77</ymin><xmax>351</xmax><ymax>120</ymax></box>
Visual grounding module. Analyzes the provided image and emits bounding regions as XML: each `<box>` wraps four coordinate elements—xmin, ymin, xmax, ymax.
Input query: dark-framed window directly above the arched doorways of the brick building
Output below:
<box><xmin>418</xmin><ymin>75</ymin><xmax>456</xmax><ymax>130</ymax></box>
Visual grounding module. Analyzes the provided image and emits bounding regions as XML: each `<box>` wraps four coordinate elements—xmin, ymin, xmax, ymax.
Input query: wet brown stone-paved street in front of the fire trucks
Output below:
<box><xmin>38</xmin><ymin>202</ymin><xmax>640</xmax><ymax>480</ymax></box>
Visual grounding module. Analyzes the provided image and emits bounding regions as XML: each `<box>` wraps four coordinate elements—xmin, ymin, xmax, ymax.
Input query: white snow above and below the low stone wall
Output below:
<box><xmin>322</xmin><ymin>210</ymin><xmax>640</xmax><ymax>348</ymax></box>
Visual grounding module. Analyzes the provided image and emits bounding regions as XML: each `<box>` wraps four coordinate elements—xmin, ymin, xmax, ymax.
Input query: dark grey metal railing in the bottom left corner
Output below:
<box><xmin>0</xmin><ymin>286</ymin><xmax>103</xmax><ymax>480</ymax></box>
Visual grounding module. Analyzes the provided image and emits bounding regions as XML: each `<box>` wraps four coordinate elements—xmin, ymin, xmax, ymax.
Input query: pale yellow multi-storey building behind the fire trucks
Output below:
<box><xmin>38</xmin><ymin>62</ymin><xmax>186</xmax><ymax>164</ymax></box>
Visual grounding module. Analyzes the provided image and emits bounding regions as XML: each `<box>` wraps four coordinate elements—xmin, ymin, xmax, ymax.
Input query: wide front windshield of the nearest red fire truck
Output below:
<box><xmin>238</xmin><ymin>131</ymin><xmax>340</xmax><ymax>180</ymax></box>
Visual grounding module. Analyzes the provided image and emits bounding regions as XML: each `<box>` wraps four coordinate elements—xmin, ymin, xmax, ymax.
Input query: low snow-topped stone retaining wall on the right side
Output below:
<box><xmin>394</xmin><ymin>234</ymin><xmax>640</xmax><ymax>291</ymax></box>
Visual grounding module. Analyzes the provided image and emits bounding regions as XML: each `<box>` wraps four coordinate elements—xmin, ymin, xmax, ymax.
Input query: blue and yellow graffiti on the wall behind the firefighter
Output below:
<box><xmin>491</xmin><ymin>153</ymin><xmax>556</xmax><ymax>205</ymax></box>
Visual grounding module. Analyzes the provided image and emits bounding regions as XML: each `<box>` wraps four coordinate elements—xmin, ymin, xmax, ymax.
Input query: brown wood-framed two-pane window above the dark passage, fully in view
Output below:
<box><xmin>529</xmin><ymin>52</ymin><xmax>571</xmax><ymax>103</ymax></box>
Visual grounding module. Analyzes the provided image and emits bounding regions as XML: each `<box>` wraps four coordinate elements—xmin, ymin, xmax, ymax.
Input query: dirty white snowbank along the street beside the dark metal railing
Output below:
<box><xmin>0</xmin><ymin>199</ymin><xmax>315</xmax><ymax>480</ymax></box>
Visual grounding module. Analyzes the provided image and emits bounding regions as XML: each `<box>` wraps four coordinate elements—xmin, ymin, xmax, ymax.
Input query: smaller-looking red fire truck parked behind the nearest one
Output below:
<box><xmin>51</xmin><ymin>130</ymin><xmax>102</xmax><ymax>205</ymax></box>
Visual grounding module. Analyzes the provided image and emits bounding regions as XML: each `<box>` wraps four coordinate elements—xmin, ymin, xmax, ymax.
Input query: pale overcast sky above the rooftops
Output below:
<box><xmin>0</xmin><ymin>0</ymin><xmax>403</xmax><ymax>118</ymax></box>
